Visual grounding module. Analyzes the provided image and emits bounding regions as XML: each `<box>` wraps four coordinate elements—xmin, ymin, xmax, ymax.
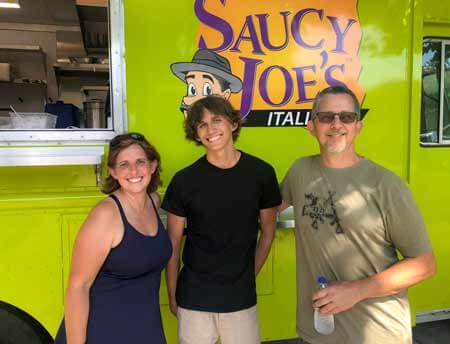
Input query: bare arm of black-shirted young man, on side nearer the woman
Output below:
<box><xmin>166</xmin><ymin>213</ymin><xmax>186</xmax><ymax>316</ymax></box>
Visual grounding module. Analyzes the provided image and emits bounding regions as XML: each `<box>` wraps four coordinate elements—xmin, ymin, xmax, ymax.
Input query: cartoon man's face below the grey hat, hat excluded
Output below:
<box><xmin>181</xmin><ymin>71</ymin><xmax>231</xmax><ymax>118</ymax></box>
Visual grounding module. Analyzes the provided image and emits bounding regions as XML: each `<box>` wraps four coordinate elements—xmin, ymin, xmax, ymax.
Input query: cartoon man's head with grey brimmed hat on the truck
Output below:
<box><xmin>170</xmin><ymin>49</ymin><xmax>242</xmax><ymax>117</ymax></box>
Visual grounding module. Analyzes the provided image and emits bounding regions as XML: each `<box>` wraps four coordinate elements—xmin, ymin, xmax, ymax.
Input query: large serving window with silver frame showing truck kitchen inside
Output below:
<box><xmin>0</xmin><ymin>0</ymin><xmax>126</xmax><ymax>145</ymax></box>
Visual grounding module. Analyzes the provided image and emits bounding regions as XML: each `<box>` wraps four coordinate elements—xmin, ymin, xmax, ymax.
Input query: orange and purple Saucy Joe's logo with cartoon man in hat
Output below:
<box><xmin>171</xmin><ymin>0</ymin><xmax>364</xmax><ymax>127</ymax></box>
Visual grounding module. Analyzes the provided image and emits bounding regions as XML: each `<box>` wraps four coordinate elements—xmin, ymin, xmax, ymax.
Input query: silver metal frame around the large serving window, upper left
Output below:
<box><xmin>0</xmin><ymin>0</ymin><xmax>127</xmax><ymax>146</ymax></box>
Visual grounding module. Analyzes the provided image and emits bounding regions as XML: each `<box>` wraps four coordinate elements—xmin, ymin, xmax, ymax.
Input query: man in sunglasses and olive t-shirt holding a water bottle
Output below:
<box><xmin>282</xmin><ymin>86</ymin><xmax>435</xmax><ymax>344</ymax></box>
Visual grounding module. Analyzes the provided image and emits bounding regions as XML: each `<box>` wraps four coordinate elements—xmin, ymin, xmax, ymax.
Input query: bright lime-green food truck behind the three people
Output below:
<box><xmin>0</xmin><ymin>0</ymin><xmax>450</xmax><ymax>343</ymax></box>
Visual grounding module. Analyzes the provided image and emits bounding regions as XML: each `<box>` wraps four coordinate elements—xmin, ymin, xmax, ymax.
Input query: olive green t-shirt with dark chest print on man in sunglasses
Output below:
<box><xmin>282</xmin><ymin>156</ymin><xmax>431</xmax><ymax>344</ymax></box>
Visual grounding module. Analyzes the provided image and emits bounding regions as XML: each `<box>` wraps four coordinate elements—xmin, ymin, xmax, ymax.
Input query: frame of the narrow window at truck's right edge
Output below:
<box><xmin>419</xmin><ymin>37</ymin><xmax>450</xmax><ymax>147</ymax></box>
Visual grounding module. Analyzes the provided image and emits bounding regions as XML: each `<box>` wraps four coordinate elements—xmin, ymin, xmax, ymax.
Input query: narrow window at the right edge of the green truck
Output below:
<box><xmin>420</xmin><ymin>38</ymin><xmax>450</xmax><ymax>145</ymax></box>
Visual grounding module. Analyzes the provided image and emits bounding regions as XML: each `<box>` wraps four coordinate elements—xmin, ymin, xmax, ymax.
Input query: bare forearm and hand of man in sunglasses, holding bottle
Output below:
<box><xmin>313</xmin><ymin>252</ymin><xmax>436</xmax><ymax>314</ymax></box>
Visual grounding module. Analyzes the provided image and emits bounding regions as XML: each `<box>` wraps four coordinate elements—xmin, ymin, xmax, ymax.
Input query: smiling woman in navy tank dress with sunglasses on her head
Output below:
<box><xmin>55</xmin><ymin>133</ymin><xmax>172</xmax><ymax>344</ymax></box>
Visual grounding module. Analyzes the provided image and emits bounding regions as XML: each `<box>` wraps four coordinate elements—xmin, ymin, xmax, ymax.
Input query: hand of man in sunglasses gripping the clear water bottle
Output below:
<box><xmin>313</xmin><ymin>281</ymin><xmax>363</xmax><ymax>315</ymax></box>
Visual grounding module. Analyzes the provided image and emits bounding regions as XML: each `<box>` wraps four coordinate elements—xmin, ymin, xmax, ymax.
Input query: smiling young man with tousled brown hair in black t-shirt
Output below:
<box><xmin>162</xmin><ymin>96</ymin><xmax>281</xmax><ymax>344</ymax></box>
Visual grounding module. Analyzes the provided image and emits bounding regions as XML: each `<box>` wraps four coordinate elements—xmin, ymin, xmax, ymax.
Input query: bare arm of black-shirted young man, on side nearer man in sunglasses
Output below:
<box><xmin>255</xmin><ymin>207</ymin><xmax>278</xmax><ymax>275</ymax></box>
